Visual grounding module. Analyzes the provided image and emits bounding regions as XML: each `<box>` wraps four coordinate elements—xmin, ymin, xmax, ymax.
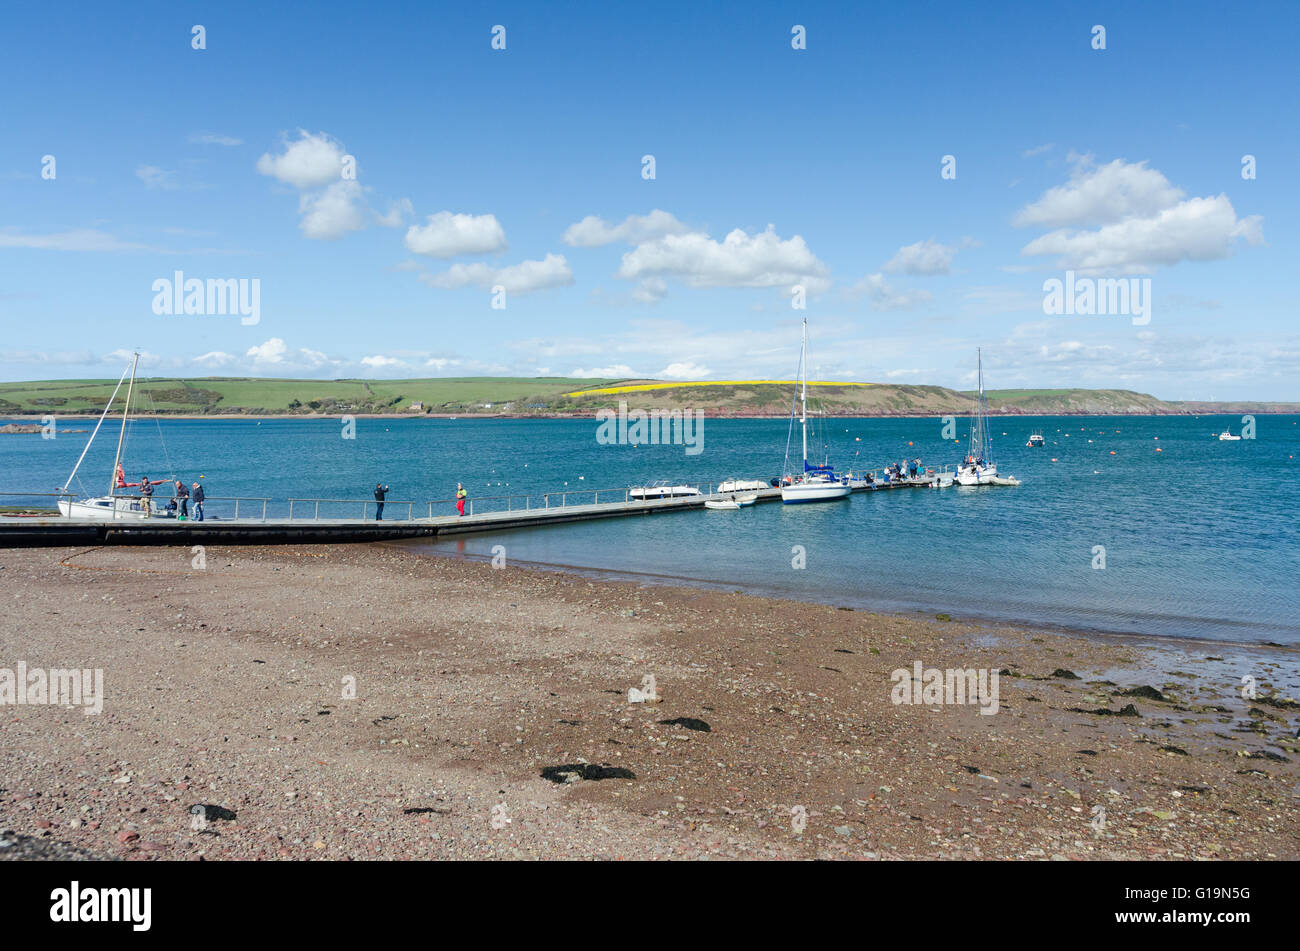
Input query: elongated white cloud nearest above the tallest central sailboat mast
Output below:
<box><xmin>618</xmin><ymin>225</ymin><xmax>831</xmax><ymax>294</ymax></box>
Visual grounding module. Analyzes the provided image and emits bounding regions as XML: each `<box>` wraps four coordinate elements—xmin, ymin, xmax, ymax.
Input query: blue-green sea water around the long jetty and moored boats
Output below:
<box><xmin>0</xmin><ymin>416</ymin><xmax>1300</xmax><ymax>644</ymax></box>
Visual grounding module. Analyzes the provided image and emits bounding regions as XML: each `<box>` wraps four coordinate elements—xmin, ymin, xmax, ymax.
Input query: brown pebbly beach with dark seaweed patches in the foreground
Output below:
<box><xmin>0</xmin><ymin>546</ymin><xmax>1300</xmax><ymax>860</ymax></box>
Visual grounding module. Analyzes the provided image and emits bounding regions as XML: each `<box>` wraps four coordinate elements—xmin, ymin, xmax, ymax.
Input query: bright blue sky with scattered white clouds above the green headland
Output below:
<box><xmin>0</xmin><ymin>3</ymin><xmax>1300</xmax><ymax>400</ymax></box>
